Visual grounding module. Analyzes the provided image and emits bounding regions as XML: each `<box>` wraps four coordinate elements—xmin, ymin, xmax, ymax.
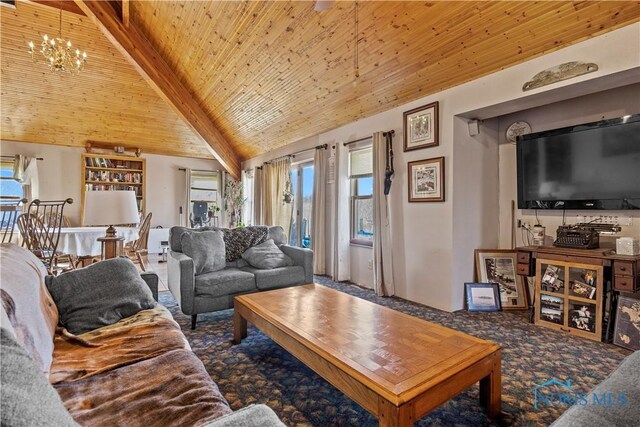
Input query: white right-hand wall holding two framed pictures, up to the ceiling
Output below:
<box><xmin>245</xmin><ymin>24</ymin><xmax>640</xmax><ymax>311</ymax></box>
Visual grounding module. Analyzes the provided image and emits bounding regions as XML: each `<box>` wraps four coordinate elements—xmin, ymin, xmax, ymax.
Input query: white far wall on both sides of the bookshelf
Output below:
<box><xmin>0</xmin><ymin>141</ymin><xmax>221</xmax><ymax>228</ymax></box>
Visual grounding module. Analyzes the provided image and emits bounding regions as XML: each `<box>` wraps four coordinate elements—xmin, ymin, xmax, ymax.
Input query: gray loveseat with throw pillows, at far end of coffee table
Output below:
<box><xmin>167</xmin><ymin>226</ymin><xmax>313</xmax><ymax>329</ymax></box>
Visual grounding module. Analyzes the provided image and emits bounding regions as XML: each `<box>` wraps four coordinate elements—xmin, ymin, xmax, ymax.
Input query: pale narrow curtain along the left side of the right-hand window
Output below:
<box><xmin>331</xmin><ymin>143</ymin><xmax>351</xmax><ymax>281</ymax></box>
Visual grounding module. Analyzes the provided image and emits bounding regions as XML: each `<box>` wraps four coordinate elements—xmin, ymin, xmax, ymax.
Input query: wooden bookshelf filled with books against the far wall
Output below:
<box><xmin>81</xmin><ymin>153</ymin><xmax>147</xmax><ymax>224</ymax></box>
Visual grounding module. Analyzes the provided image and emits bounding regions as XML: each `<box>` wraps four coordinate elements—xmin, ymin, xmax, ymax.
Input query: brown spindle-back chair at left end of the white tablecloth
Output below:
<box><xmin>18</xmin><ymin>199</ymin><xmax>74</xmax><ymax>275</ymax></box>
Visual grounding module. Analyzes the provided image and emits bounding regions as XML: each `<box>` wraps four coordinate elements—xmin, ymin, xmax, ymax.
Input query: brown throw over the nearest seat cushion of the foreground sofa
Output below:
<box><xmin>54</xmin><ymin>350</ymin><xmax>231</xmax><ymax>427</ymax></box>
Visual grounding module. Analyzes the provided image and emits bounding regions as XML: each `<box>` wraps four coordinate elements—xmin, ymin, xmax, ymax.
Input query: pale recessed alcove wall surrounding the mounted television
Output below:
<box><xmin>498</xmin><ymin>84</ymin><xmax>640</xmax><ymax>248</ymax></box>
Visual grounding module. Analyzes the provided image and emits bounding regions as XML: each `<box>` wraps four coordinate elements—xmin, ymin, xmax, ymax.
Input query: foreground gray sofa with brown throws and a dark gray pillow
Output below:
<box><xmin>0</xmin><ymin>244</ymin><xmax>283</xmax><ymax>427</ymax></box>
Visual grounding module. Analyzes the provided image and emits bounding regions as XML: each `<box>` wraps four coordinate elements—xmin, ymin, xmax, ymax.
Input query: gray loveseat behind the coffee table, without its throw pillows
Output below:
<box><xmin>167</xmin><ymin>226</ymin><xmax>313</xmax><ymax>329</ymax></box>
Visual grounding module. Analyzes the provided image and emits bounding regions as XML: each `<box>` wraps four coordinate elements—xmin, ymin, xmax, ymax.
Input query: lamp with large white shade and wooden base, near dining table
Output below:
<box><xmin>84</xmin><ymin>191</ymin><xmax>140</xmax><ymax>259</ymax></box>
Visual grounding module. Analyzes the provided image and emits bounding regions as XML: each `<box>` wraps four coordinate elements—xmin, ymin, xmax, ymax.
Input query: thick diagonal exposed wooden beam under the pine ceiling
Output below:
<box><xmin>74</xmin><ymin>0</ymin><xmax>240</xmax><ymax>179</ymax></box>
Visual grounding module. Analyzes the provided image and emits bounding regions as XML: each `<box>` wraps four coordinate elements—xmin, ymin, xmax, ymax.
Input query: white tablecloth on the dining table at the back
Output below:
<box><xmin>58</xmin><ymin>227</ymin><xmax>138</xmax><ymax>256</ymax></box>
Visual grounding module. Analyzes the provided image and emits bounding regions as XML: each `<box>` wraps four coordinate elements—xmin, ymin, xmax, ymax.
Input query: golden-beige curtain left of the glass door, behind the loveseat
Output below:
<box><xmin>262</xmin><ymin>157</ymin><xmax>293</xmax><ymax>234</ymax></box>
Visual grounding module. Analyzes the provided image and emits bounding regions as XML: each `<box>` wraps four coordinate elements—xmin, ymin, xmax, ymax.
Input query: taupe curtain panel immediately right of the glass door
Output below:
<box><xmin>311</xmin><ymin>148</ymin><xmax>327</xmax><ymax>274</ymax></box>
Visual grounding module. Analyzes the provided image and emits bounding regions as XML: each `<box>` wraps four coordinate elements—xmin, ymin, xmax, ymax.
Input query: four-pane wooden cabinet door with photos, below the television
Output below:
<box><xmin>535</xmin><ymin>258</ymin><xmax>606</xmax><ymax>341</ymax></box>
